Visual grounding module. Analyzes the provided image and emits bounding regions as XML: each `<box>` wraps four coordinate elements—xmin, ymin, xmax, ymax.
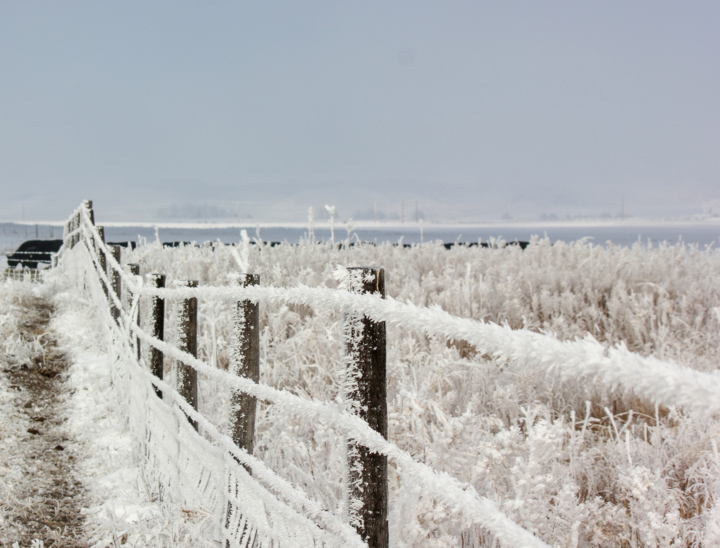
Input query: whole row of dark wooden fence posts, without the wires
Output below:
<box><xmin>65</xmin><ymin>200</ymin><xmax>389</xmax><ymax>548</ymax></box>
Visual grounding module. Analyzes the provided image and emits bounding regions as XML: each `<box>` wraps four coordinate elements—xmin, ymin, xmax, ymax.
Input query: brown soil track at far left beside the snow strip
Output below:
<box><xmin>0</xmin><ymin>299</ymin><xmax>87</xmax><ymax>548</ymax></box>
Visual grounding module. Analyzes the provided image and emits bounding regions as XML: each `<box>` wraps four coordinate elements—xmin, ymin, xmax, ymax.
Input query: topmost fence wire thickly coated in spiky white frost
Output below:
<box><xmin>71</xmin><ymin>208</ymin><xmax>720</xmax><ymax>418</ymax></box>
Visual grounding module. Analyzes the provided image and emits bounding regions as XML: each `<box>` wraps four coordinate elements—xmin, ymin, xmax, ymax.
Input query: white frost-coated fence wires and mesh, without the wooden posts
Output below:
<box><xmin>57</xmin><ymin>202</ymin><xmax>720</xmax><ymax>546</ymax></box>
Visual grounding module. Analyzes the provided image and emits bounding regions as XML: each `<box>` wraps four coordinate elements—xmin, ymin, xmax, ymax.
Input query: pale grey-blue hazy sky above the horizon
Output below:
<box><xmin>0</xmin><ymin>0</ymin><xmax>720</xmax><ymax>221</ymax></box>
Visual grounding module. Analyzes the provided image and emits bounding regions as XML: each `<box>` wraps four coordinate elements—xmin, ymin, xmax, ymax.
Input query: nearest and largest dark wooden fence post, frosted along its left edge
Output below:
<box><xmin>346</xmin><ymin>267</ymin><xmax>389</xmax><ymax>548</ymax></box>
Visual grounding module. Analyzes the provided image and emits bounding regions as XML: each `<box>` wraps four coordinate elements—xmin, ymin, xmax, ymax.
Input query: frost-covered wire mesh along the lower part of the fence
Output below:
<box><xmin>60</xmin><ymin>204</ymin><xmax>372</xmax><ymax>547</ymax></box>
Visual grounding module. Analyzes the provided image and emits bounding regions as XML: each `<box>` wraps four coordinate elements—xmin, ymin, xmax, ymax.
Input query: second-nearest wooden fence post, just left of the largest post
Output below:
<box><xmin>230</xmin><ymin>274</ymin><xmax>260</xmax><ymax>458</ymax></box>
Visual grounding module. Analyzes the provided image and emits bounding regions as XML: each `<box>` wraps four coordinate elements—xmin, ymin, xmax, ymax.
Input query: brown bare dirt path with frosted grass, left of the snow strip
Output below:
<box><xmin>0</xmin><ymin>296</ymin><xmax>86</xmax><ymax>548</ymax></box>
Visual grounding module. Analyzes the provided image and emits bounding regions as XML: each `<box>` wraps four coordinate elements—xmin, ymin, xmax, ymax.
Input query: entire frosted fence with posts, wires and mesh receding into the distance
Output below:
<box><xmin>59</xmin><ymin>202</ymin><xmax>720</xmax><ymax>548</ymax></box>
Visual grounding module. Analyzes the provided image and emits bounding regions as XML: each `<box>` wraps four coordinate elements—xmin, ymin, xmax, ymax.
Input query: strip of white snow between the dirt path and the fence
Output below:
<box><xmin>52</xmin><ymin>284</ymin><xmax>214</xmax><ymax>548</ymax></box>
